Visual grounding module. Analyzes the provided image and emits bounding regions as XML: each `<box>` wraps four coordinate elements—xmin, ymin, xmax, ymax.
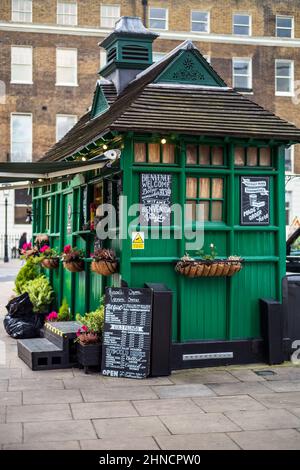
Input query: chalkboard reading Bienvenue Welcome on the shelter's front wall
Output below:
<box><xmin>140</xmin><ymin>173</ymin><xmax>172</xmax><ymax>225</ymax></box>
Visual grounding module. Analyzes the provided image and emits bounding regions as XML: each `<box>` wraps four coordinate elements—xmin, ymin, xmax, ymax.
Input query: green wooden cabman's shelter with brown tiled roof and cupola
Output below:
<box><xmin>11</xmin><ymin>17</ymin><xmax>300</xmax><ymax>368</ymax></box>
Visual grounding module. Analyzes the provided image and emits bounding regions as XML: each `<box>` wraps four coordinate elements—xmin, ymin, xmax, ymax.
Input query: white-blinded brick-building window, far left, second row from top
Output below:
<box><xmin>11</xmin><ymin>46</ymin><xmax>32</xmax><ymax>84</ymax></box>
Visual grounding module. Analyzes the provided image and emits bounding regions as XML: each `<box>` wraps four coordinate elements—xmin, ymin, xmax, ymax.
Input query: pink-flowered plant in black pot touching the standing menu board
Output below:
<box><xmin>75</xmin><ymin>306</ymin><xmax>104</xmax><ymax>373</ymax></box>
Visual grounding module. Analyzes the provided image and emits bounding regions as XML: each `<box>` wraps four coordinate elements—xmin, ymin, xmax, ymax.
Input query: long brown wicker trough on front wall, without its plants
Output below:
<box><xmin>175</xmin><ymin>259</ymin><xmax>242</xmax><ymax>278</ymax></box>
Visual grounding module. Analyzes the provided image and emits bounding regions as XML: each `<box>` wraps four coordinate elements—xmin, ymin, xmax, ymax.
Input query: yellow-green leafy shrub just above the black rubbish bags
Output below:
<box><xmin>21</xmin><ymin>276</ymin><xmax>54</xmax><ymax>313</ymax></box>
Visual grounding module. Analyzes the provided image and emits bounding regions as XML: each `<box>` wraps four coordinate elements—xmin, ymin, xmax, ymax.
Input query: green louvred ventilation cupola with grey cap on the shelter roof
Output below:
<box><xmin>99</xmin><ymin>16</ymin><xmax>158</xmax><ymax>94</ymax></box>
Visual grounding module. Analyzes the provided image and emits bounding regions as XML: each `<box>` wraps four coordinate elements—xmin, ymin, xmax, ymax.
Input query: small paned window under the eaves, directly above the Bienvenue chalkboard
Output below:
<box><xmin>134</xmin><ymin>142</ymin><xmax>176</xmax><ymax>164</ymax></box>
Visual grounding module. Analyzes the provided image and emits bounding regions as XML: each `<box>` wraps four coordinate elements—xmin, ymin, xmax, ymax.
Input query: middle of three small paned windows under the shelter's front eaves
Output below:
<box><xmin>186</xmin><ymin>144</ymin><xmax>225</xmax><ymax>166</ymax></box>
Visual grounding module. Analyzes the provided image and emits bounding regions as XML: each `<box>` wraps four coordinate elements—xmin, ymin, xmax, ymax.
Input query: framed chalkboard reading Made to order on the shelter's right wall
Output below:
<box><xmin>241</xmin><ymin>176</ymin><xmax>270</xmax><ymax>225</ymax></box>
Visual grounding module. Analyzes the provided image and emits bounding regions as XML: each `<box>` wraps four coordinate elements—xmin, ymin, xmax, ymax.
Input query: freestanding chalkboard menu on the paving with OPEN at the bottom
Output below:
<box><xmin>102</xmin><ymin>287</ymin><xmax>152</xmax><ymax>379</ymax></box>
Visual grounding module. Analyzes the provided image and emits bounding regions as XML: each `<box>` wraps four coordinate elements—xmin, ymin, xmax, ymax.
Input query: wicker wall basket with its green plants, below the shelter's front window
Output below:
<box><xmin>175</xmin><ymin>243</ymin><xmax>243</xmax><ymax>278</ymax></box>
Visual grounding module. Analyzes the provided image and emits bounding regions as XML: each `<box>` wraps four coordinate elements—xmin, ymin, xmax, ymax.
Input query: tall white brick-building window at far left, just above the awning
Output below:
<box><xmin>11</xmin><ymin>114</ymin><xmax>32</xmax><ymax>162</ymax></box>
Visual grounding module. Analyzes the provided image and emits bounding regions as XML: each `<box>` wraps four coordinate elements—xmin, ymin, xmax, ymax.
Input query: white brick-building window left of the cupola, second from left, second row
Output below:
<box><xmin>56</xmin><ymin>49</ymin><xmax>78</xmax><ymax>86</ymax></box>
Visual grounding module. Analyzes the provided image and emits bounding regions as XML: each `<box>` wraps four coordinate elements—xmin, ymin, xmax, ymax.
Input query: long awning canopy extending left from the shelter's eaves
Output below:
<box><xmin>0</xmin><ymin>155</ymin><xmax>110</xmax><ymax>190</ymax></box>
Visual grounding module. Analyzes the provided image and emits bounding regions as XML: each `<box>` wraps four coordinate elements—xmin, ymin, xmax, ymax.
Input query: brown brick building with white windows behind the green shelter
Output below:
<box><xmin>0</xmin><ymin>0</ymin><xmax>300</xmax><ymax>246</ymax></box>
